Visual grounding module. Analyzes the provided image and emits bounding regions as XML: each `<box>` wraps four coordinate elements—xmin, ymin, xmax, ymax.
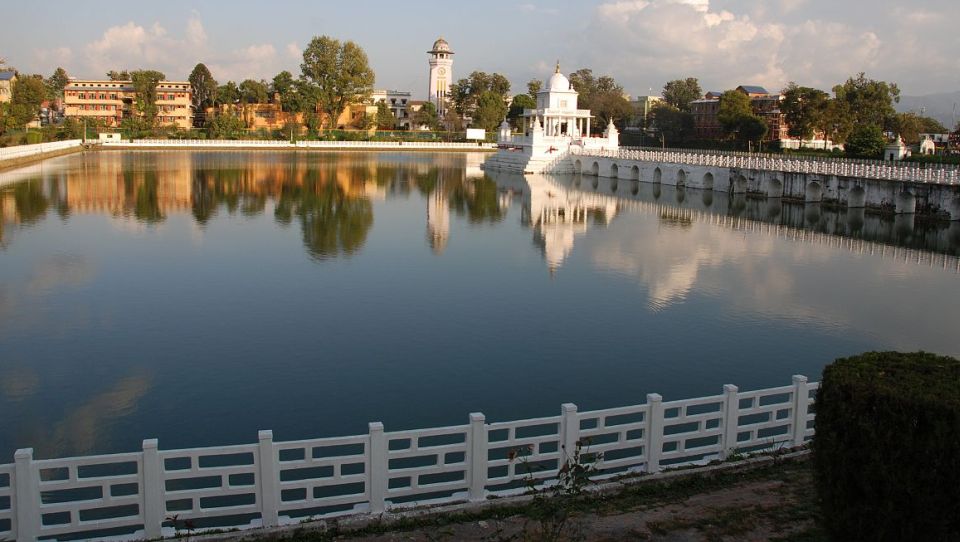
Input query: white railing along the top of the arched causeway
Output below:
<box><xmin>573</xmin><ymin>148</ymin><xmax>960</xmax><ymax>185</ymax></box>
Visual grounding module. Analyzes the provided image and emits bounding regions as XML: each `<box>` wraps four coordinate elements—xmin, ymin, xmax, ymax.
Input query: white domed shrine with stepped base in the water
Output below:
<box><xmin>483</xmin><ymin>63</ymin><xmax>620</xmax><ymax>173</ymax></box>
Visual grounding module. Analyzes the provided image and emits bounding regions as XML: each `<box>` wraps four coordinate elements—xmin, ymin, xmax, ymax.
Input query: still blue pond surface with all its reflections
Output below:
<box><xmin>0</xmin><ymin>151</ymin><xmax>960</xmax><ymax>463</ymax></box>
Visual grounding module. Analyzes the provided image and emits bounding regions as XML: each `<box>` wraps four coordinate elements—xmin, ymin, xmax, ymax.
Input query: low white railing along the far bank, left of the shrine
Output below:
<box><xmin>104</xmin><ymin>139</ymin><xmax>496</xmax><ymax>150</ymax></box>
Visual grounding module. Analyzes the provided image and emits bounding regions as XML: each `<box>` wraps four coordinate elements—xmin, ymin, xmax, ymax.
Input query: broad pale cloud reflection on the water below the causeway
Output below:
<box><xmin>587</xmin><ymin>214</ymin><xmax>960</xmax><ymax>355</ymax></box>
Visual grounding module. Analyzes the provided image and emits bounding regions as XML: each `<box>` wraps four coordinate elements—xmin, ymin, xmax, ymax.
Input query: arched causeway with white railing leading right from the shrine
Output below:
<box><xmin>569</xmin><ymin>146</ymin><xmax>960</xmax><ymax>220</ymax></box>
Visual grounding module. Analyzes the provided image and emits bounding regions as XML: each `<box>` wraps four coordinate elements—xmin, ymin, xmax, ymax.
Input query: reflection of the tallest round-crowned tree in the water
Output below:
<box><xmin>274</xmin><ymin>170</ymin><xmax>373</xmax><ymax>260</ymax></box>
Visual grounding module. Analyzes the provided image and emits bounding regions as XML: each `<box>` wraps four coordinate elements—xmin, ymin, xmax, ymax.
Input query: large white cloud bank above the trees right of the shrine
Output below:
<box><xmin>582</xmin><ymin>0</ymin><xmax>960</xmax><ymax>95</ymax></box>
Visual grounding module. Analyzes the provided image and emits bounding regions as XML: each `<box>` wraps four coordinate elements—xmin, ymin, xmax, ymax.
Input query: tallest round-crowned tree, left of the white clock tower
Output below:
<box><xmin>300</xmin><ymin>36</ymin><xmax>375</xmax><ymax>130</ymax></box>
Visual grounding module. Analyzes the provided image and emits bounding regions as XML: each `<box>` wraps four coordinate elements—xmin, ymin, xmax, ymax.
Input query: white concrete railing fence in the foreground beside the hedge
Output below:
<box><xmin>0</xmin><ymin>376</ymin><xmax>818</xmax><ymax>540</ymax></box>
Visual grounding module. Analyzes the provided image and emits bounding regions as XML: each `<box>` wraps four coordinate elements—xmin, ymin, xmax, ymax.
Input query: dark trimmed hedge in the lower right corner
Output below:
<box><xmin>813</xmin><ymin>352</ymin><xmax>960</xmax><ymax>541</ymax></box>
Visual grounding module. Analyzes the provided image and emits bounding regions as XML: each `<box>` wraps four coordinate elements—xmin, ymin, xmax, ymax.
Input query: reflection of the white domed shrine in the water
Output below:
<box><xmin>524</xmin><ymin>175</ymin><xmax>618</xmax><ymax>274</ymax></box>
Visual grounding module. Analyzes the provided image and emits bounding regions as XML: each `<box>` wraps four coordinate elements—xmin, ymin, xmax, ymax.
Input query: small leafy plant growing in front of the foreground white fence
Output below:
<box><xmin>508</xmin><ymin>438</ymin><xmax>603</xmax><ymax>542</ymax></box>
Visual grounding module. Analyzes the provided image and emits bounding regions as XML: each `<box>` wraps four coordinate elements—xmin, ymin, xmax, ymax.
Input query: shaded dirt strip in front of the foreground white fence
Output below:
<box><xmin>256</xmin><ymin>460</ymin><xmax>825</xmax><ymax>542</ymax></box>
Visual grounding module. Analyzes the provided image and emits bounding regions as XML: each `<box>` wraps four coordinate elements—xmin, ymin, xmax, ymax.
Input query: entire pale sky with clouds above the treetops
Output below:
<box><xmin>0</xmin><ymin>0</ymin><xmax>960</xmax><ymax>98</ymax></box>
